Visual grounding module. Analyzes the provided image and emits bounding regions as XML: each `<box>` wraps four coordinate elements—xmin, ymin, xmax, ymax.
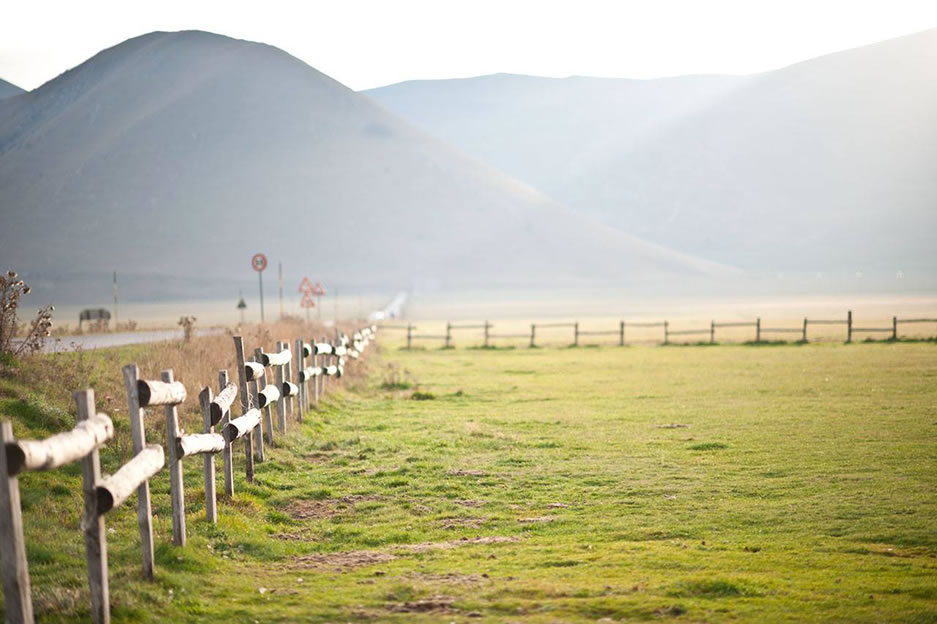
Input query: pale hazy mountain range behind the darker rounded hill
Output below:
<box><xmin>367</xmin><ymin>29</ymin><xmax>937</xmax><ymax>276</ymax></box>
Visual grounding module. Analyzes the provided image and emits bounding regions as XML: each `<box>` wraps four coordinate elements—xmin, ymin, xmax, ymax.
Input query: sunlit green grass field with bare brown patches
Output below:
<box><xmin>0</xmin><ymin>344</ymin><xmax>937</xmax><ymax>623</ymax></box>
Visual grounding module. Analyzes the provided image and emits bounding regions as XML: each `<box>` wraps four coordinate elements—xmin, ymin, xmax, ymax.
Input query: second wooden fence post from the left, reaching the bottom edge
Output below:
<box><xmin>75</xmin><ymin>388</ymin><xmax>111</xmax><ymax>624</ymax></box>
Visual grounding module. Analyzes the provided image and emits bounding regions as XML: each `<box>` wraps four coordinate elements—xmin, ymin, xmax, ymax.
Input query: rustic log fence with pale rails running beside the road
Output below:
<box><xmin>0</xmin><ymin>326</ymin><xmax>377</xmax><ymax>624</ymax></box>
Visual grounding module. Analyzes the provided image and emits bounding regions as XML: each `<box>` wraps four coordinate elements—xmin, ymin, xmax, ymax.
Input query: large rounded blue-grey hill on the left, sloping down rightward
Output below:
<box><xmin>0</xmin><ymin>32</ymin><xmax>727</xmax><ymax>302</ymax></box>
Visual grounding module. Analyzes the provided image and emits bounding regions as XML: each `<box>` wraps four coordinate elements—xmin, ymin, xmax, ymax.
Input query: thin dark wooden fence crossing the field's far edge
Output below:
<box><xmin>381</xmin><ymin>310</ymin><xmax>937</xmax><ymax>349</ymax></box>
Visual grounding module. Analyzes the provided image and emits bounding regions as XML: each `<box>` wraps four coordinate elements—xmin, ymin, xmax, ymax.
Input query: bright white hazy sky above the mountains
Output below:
<box><xmin>0</xmin><ymin>0</ymin><xmax>937</xmax><ymax>89</ymax></box>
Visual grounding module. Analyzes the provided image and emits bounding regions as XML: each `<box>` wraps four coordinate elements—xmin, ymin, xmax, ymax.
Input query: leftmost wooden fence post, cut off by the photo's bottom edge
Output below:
<box><xmin>0</xmin><ymin>421</ymin><xmax>34</xmax><ymax>624</ymax></box>
